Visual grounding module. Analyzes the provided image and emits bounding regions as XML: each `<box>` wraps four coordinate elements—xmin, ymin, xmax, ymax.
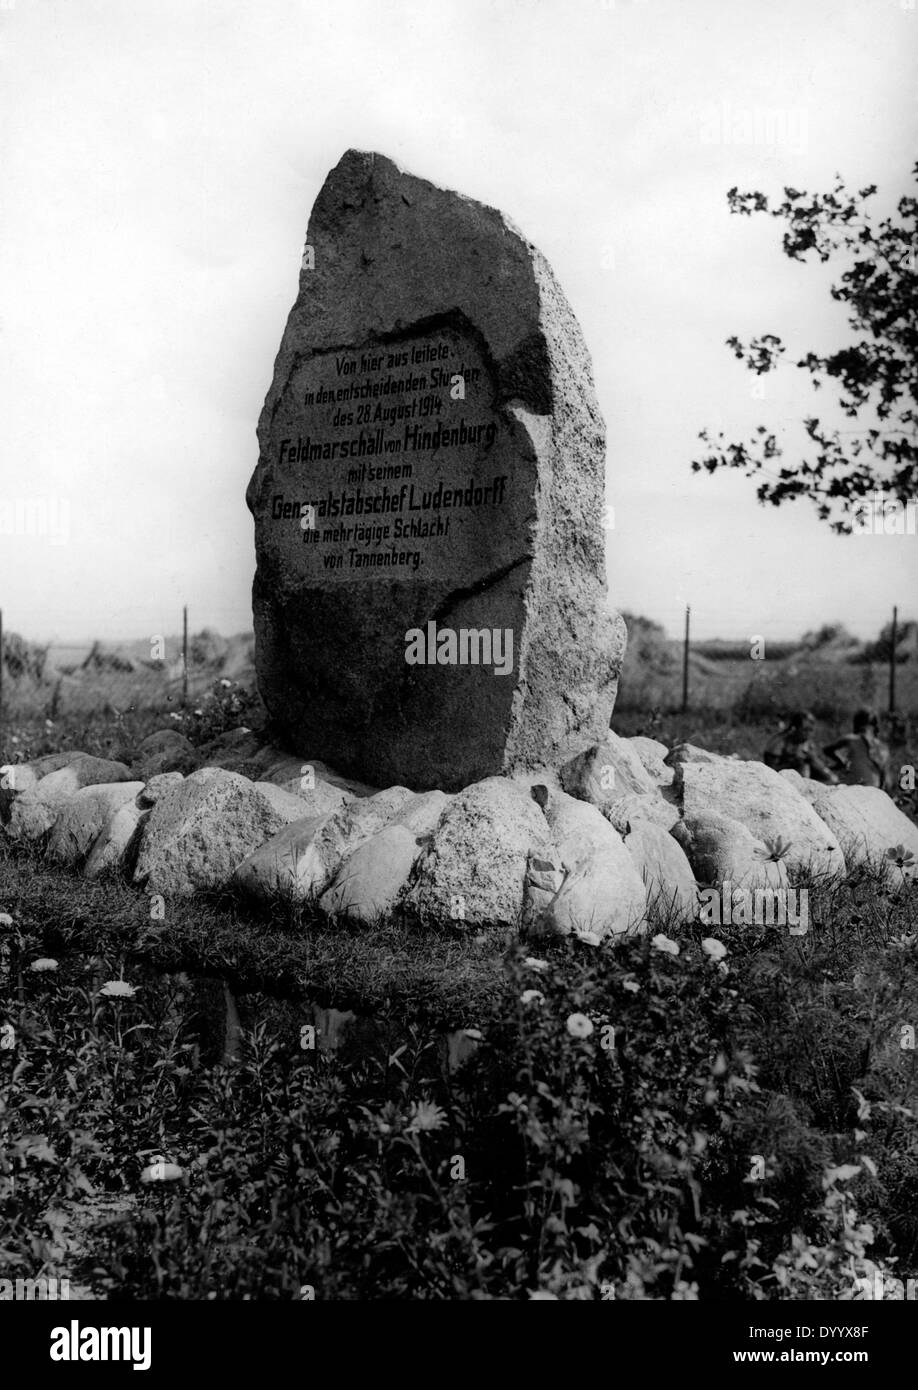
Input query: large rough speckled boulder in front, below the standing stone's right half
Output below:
<box><xmin>406</xmin><ymin>777</ymin><xmax>554</xmax><ymax>926</ymax></box>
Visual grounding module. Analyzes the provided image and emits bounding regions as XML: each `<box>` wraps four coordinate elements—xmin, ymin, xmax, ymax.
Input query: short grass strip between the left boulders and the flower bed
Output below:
<box><xmin>0</xmin><ymin>838</ymin><xmax>505</xmax><ymax>1027</ymax></box>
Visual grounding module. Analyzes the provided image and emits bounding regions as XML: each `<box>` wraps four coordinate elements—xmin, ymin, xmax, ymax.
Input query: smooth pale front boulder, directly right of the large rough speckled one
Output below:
<box><xmin>534</xmin><ymin>792</ymin><xmax>647</xmax><ymax>941</ymax></box>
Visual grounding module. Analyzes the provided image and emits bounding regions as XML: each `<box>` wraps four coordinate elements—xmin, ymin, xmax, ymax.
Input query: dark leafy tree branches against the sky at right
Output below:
<box><xmin>691</xmin><ymin>164</ymin><xmax>918</xmax><ymax>532</ymax></box>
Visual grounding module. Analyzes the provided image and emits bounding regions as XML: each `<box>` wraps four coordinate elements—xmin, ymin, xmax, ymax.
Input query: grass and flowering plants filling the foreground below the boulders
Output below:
<box><xmin>0</xmin><ymin>847</ymin><xmax>918</xmax><ymax>1300</ymax></box>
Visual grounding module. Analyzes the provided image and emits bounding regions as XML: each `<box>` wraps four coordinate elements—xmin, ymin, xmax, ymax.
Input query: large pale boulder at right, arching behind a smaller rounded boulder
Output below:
<box><xmin>675</xmin><ymin>758</ymin><xmax>844</xmax><ymax>878</ymax></box>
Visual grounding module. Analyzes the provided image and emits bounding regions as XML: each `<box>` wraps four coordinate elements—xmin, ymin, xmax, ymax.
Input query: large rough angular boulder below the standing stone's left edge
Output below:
<box><xmin>135</xmin><ymin>767</ymin><xmax>318</xmax><ymax>897</ymax></box>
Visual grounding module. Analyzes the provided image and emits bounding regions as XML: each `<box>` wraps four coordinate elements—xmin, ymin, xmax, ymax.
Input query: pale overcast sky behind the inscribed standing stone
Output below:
<box><xmin>0</xmin><ymin>0</ymin><xmax>918</xmax><ymax>641</ymax></box>
